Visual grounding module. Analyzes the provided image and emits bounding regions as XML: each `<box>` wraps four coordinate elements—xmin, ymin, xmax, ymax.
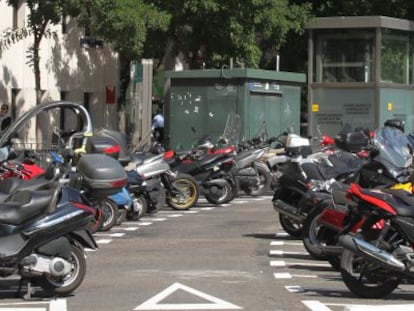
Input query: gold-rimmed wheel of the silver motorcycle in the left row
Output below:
<box><xmin>167</xmin><ymin>174</ymin><xmax>200</xmax><ymax>210</ymax></box>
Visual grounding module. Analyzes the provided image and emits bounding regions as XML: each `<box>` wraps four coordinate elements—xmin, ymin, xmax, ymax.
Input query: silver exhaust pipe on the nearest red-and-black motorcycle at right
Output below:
<box><xmin>338</xmin><ymin>234</ymin><xmax>406</xmax><ymax>271</ymax></box>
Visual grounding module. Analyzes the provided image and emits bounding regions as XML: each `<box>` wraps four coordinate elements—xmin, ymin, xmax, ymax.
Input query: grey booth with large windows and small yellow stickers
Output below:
<box><xmin>308</xmin><ymin>16</ymin><xmax>414</xmax><ymax>136</ymax></box>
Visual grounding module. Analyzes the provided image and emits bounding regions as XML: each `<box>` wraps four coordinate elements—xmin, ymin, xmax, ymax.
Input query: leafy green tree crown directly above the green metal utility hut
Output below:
<box><xmin>145</xmin><ymin>0</ymin><xmax>310</xmax><ymax>69</ymax></box>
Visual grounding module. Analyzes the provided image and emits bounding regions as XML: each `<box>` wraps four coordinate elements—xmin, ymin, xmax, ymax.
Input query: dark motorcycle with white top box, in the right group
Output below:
<box><xmin>272</xmin><ymin>133</ymin><xmax>364</xmax><ymax>237</ymax></box>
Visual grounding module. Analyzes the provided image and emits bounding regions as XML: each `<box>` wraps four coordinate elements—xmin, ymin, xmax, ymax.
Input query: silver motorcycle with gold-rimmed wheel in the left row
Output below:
<box><xmin>95</xmin><ymin>129</ymin><xmax>199</xmax><ymax>212</ymax></box>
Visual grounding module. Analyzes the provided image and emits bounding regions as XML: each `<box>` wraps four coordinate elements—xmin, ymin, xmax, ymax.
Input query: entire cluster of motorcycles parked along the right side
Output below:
<box><xmin>272</xmin><ymin>120</ymin><xmax>414</xmax><ymax>298</ymax></box>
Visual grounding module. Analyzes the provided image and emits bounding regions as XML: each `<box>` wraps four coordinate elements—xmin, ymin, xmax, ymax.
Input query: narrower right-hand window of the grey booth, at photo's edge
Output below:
<box><xmin>381</xmin><ymin>29</ymin><xmax>413</xmax><ymax>84</ymax></box>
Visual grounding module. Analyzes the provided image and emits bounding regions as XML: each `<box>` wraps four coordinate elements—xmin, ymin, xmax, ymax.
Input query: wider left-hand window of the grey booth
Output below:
<box><xmin>314</xmin><ymin>29</ymin><xmax>375</xmax><ymax>83</ymax></box>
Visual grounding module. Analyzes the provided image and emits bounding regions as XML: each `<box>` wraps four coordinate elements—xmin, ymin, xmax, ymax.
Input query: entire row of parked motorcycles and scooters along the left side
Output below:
<box><xmin>0</xmin><ymin>101</ymin><xmax>288</xmax><ymax>299</ymax></box>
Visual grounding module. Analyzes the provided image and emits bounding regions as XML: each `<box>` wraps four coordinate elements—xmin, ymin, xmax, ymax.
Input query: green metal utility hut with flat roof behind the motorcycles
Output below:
<box><xmin>165</xmin><ymin>68</ymin><xmax>306</xmax><ymax>149</ymax></box>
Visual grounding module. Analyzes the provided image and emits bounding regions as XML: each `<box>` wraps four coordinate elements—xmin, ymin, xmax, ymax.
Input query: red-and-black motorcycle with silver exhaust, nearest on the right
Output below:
<box><xmin>338</xmin><ymin>184</ymin><xmax>414</xmax><ymax>298</ymax></box>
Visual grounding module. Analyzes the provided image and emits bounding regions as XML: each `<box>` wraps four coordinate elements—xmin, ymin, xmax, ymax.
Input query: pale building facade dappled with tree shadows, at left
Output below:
<box><xmin>0</xmin><ymin>0</ymin><xmax>119</xmax><ymax>140</ymax></box>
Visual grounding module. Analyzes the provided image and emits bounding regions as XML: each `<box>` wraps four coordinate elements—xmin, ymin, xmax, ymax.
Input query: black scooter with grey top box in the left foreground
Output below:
<box><xmin>0</xmin><ymin>154</ymin><xmax>126</xmax><ymax>299</ymax></box>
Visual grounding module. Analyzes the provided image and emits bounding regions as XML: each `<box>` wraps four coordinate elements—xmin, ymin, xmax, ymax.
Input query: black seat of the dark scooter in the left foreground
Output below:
<box><xmin>0</xmin><ymin>189</ymin><xmax>56</xmax><ymax>225</ymax></box>
